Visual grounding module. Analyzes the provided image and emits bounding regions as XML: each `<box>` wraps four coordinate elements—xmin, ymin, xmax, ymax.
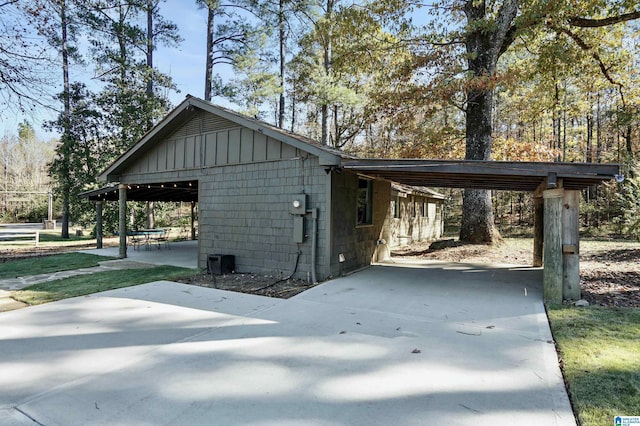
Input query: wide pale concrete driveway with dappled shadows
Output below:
<box><xmin>0</xmin><ymin>262</ymin><xmax>575</xmax><ymax>426</ymax></box>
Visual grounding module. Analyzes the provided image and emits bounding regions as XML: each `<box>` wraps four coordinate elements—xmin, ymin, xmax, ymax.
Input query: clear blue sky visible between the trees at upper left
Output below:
<box><xmin>0</xmin><ymin>0</ymin><xmax>228</xmax><ymax>139</ymax></box>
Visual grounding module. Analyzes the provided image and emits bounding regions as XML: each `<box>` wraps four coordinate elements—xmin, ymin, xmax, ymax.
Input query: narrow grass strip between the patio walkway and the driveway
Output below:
<box><xmin>13</xmin><ymin>266</ymin><xmax>199</xmax><ymax>305</ymax></box>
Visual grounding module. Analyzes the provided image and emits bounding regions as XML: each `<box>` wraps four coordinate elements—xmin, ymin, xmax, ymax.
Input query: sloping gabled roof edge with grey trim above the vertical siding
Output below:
<box><xmin>99</xmin><ymin>95</ymin><xmax>355</xmax><ymax>182</ymax></box>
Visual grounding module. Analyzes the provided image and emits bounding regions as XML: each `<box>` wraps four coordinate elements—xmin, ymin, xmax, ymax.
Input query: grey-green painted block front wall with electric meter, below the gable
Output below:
<box><xmin>198</xmin><ymin>154</ymin><xmax>329</xmax><ymax>279</ymax></box>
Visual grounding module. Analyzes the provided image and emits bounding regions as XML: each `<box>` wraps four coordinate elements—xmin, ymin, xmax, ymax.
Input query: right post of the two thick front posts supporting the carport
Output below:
<box><xmin>562</xmin><ymin>190</ymin><xmax>580</xmax><ymax>300</ymax></box>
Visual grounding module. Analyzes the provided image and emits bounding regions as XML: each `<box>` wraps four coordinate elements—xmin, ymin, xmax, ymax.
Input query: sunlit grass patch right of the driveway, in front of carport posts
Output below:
<box><xmin>547</xmin><ymin>307</ymin><xmax>640</xmax><ymax>426</ymax></box>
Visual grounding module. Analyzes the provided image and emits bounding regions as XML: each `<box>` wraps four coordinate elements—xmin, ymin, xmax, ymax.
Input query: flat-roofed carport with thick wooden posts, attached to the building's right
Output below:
<box><xmin>342</xmin><ymin>159</ymin><xmax>620</xmax><ymax>302</ymax></box>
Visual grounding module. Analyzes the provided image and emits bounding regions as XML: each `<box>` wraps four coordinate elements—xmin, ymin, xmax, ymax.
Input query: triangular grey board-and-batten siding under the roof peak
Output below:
<box><xmin>123</xmin><ymin>112</ymin><xmax>298</xmax><ymax>181</ymax></box>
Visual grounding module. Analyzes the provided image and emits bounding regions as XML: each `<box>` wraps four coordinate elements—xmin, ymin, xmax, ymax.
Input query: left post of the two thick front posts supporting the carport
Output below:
<box><xmin>542</xmin><ymin>188</ymin><xmax>564</xmax><ymax>303</ymax></box>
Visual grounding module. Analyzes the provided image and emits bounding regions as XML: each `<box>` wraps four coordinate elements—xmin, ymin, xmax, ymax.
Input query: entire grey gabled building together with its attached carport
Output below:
<box><xmin>84</xmin><ymin>96</ymin><xmax>619</xmax><ymax>301</ymax></box>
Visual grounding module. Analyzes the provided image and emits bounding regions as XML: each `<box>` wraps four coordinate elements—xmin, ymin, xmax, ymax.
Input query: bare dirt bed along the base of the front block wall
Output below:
<box><xmin>180</xmin><ymin>273</ymin><xmax>314</xmax><ymax>299</ymax></box>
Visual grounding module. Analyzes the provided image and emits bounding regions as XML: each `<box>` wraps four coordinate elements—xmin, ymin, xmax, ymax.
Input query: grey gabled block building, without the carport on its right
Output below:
<box><xmin>87</xmin><ymin>96</ymin><xmax>416</xmax><ymax>281</ymax></box>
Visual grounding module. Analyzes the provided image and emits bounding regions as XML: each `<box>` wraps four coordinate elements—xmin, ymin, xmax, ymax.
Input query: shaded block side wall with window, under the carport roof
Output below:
<box><xmin>331</xmin><ymin>172</ymin><xmax>391</xmax><ymax>275</ymax></box>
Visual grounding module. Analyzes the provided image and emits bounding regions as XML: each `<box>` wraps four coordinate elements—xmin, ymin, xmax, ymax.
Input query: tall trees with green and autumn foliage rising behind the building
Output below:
<box><xmin>0</xmin><ymin>0</ymin><xmax>640</xmax><ymax>242</ymax></box>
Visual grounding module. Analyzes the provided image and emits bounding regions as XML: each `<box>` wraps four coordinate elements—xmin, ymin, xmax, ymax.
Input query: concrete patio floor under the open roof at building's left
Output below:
<box><xmin>81</xmin><ymin>240</ymin><xmax>198</xmax><ymax>269</ymax></box>
